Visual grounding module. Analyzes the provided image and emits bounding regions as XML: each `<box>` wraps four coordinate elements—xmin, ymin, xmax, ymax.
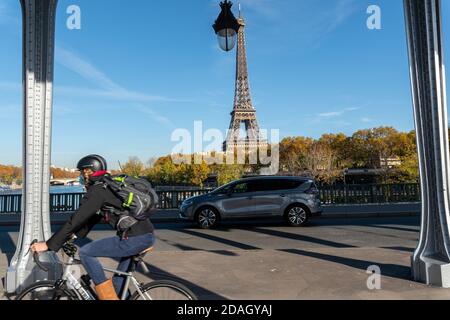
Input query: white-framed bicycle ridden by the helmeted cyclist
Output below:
<box><xmin>16</xmin><ymin>240</ymin><xmax>197</xmax><ymax>300</ymax></box>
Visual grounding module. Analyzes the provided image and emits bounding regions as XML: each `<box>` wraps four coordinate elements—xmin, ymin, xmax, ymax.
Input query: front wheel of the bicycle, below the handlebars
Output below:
<box><xmin>16</xmin><ymin>281</ymin><xmax>78</xmax><ymax>300</ymax></box>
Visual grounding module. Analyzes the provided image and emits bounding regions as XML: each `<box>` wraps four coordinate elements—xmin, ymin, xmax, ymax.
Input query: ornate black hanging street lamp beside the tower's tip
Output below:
<box><xmin>213</xmin><ymin>0</ymin><xmax>240</xmax><ymax>51</ymax></box>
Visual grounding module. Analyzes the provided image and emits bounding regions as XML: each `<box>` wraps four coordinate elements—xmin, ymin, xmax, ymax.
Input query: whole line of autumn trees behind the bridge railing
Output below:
<box><xmin>0</xmin><ymin>127</ymin><xmax>422</xmax><ymax>187</ymax></box>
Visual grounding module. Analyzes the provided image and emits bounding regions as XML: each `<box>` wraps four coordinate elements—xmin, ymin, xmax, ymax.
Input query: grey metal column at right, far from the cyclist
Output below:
<box><xmin>404</xmin><ymin>0</ymin><xmax>450</xmax><ymax>288</ymax></box>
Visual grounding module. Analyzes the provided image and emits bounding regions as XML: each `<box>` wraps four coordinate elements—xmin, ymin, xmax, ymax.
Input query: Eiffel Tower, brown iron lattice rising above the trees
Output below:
<box><xmin>223</xmin><ymin>17</ymin><xmax>267</xmax><ymax>152</ymax></box>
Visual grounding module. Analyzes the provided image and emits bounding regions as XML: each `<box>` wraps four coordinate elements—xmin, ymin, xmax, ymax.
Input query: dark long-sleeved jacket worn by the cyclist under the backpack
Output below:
<box><xmin>47</xmin><ymin>173</ymin><xmax>154</xmax><ymax>252</ymax></box>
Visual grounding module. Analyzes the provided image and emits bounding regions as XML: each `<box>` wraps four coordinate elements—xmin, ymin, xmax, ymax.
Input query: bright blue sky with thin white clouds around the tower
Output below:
<box><xmin>0</xmin><ymin>0</ymin><xmax>450</xmax><ymax>167</ymax></box>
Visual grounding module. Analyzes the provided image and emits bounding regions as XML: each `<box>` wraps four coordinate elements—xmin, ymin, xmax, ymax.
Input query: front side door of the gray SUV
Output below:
<box><xmin>221</xmin><ymin>182</ymin><xmax>253</xmax><ymax>218</ymax></box>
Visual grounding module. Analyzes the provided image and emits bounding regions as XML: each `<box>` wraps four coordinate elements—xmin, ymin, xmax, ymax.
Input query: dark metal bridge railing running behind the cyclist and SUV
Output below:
<box><xmin>0</xmin><ymin>184</ymin><xmax>421</xmax><ymax>214</ymax></box>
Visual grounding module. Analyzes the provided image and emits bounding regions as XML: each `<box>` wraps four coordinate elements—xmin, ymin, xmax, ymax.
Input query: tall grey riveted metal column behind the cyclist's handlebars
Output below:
<box><xmin>6</xmin><ymin>0</ymin><xmax>61</xmax><ymax>293</ymax></box>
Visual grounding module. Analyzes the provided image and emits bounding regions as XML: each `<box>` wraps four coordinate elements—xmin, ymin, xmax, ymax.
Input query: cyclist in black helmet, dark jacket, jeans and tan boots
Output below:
<box><xmin>31</xmin><ymin>155</ymin><xmax>155</xmax><ymax>300</ymax></box>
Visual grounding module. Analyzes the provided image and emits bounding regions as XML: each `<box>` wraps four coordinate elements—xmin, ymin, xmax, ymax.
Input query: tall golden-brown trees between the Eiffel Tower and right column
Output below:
<box><xmin>280</xmin><ymin>127</ymin><xmax>420</xmax><ymax>183</ymax></box>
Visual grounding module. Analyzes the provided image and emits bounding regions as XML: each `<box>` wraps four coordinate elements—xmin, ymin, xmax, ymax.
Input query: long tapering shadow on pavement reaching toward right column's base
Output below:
<box><xmin>279</xmin><ymin>249</ymin><xmax>412</xmax><ymax>280</ymax></box>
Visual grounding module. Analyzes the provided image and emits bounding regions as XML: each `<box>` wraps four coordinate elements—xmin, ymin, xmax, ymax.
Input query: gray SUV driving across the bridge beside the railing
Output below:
<box><xmin>179</xmin><ymin>177</ymin><xmax>322</xmax><ymax>229</ymax></box>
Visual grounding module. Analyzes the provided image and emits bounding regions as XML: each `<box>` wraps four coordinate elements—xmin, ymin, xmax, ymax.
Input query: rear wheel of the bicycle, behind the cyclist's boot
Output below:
<box><xmin>131</xmin><ymin>280</ymin><xmax>197</xmax><ymax>300</ymax></box>
